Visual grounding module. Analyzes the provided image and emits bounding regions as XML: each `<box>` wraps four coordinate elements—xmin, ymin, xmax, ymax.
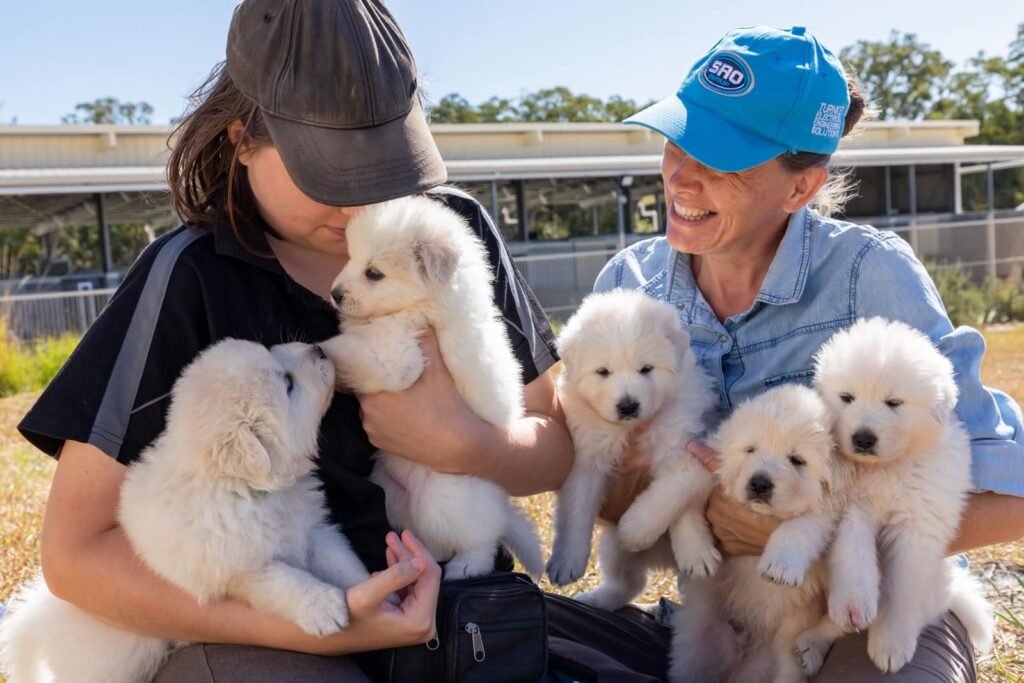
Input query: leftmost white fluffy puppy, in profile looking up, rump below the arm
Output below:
<box><xmin>0</xmin><ymin>339</ymin><xmax>368</xmax><ymax>683</ymax></box>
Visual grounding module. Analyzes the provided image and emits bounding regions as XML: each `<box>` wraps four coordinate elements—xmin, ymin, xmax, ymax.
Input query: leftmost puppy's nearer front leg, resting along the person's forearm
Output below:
<box><xmin>228</xmin><ymin>560</ymin><xmax>348</xmax><ymax>637</ymax></box>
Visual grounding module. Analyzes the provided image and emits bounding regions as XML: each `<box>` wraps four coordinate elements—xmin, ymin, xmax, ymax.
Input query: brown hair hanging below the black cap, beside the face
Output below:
<box><xmin>167</xmin><ymin>62</ymin><xmax>272</xmax><ymax>251</ymax></box>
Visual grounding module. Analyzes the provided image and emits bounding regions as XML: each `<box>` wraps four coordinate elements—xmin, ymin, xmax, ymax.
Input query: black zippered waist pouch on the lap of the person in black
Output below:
<box><xmin>387</xmin><ymin>572</ymin><xmax>548</xmax><ymax>683</ymax></box>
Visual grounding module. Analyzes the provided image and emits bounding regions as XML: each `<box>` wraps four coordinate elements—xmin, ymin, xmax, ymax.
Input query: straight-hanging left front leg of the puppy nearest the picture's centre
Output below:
<box><xmin>547</xmin><ymin>464</ymin><xmax>608</xmax><ymax>586</ymax></box>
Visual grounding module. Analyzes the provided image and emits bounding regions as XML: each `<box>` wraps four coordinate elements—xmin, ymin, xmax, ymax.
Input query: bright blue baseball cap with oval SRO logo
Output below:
<box><xmin>624</xmin><ymin>27</ymin><xmax>850</xmax><ymax>173</ymax></box>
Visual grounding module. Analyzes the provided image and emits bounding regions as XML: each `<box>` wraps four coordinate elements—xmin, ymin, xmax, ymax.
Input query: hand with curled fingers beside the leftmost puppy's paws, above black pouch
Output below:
<box><xmin>317</xmin><ymin>530</ymin><xmax>441</xmax><ymax>654</ymax></box>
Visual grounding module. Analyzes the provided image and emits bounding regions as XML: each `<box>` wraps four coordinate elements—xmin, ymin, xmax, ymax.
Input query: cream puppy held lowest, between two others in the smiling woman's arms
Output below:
<box><xmin>670</xmin><ymin>385</ymin><xmax>849</xmax><ymax>683</ymax></box>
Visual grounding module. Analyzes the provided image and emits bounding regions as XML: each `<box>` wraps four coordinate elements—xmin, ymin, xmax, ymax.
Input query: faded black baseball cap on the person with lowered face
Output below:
<box><xmin>227</xmin><ymin>0</ymin><xmax>447</xmax><ymax>206</ymax></box>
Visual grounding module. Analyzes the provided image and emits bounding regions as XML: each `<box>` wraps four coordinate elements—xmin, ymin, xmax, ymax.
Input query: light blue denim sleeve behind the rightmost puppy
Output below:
<box><xmin>856</xmin><ymin>236</ymin><xmax>1024</xmax><ymax>496</ymax></box>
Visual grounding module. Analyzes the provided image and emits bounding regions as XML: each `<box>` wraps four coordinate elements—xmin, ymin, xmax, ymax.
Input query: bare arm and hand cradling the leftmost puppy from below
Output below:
<box><xmin>42</xmin><ymin>441</ymin><xmax>440</xmax><ymax>654</ymax></box>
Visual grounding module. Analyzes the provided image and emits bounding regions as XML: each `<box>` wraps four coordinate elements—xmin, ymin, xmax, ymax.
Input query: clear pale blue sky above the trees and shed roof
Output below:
<box><xmin>0</xmin><ymin>0</ymin><xmax>1024</xmax><ymax>124</ymax></box>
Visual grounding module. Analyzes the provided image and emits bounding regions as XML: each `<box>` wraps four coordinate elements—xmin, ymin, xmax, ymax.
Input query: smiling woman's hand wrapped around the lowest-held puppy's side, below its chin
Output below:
<box><xmin>686</xmin><ymin>441</ymin><xmax>778</xmax><ymax>557</ymax></box>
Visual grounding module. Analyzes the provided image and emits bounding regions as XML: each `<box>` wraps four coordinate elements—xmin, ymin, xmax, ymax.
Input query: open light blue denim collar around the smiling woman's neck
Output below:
<box><xmin>663</xmin><ymin>207</ymin><xmax>813</xmax><ymax>333</ymax></box>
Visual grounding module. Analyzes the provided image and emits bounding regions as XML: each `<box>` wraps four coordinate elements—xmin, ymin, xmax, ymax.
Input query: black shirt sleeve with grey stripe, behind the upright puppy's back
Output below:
<box><xmin>431</xmin><ymin>187</ymin><xmax>558</xmax><ymax>384</ymax></box>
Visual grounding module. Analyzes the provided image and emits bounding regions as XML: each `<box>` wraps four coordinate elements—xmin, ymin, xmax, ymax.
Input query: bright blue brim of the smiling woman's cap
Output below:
<box><xmin>623</xmin><ymin>95</ymin><xmax>785</xmax><ymax>173</ymax></box>
